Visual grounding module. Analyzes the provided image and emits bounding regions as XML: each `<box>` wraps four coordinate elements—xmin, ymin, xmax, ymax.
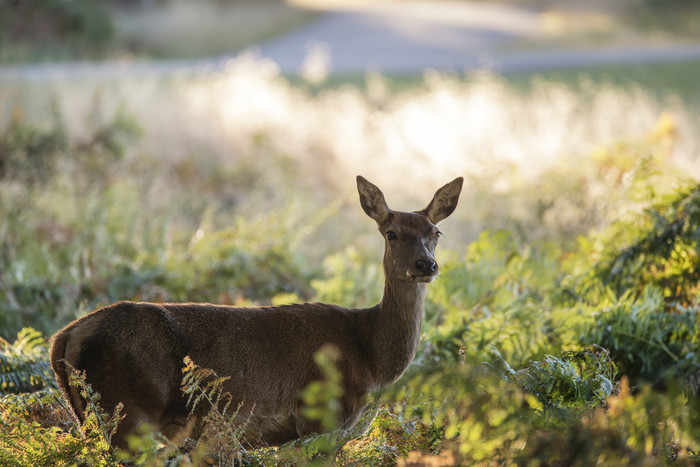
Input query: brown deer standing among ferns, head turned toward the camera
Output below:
<box><xmin>51</xmin><ymin>176</ymin><xmax>463</xmax><ymax>447</ymax></box>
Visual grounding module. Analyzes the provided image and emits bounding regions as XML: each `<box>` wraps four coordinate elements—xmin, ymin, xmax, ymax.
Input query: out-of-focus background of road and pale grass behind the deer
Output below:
<box><xmin>0</xmin><ymin>0</ymin><xmax>700</xmax><ymax>335</ymax></box>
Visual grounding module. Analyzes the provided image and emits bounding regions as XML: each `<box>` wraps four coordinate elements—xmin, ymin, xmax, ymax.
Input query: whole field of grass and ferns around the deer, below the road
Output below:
<box><xmin>0</xmin><ymin>33</ymin><xmax>700</xmax><ymax>466</ymax></box>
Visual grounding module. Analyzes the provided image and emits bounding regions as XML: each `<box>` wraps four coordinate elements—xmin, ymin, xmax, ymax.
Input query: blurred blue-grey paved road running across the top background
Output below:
<box><xmin>0</xmin><ymin>0</ymin><xmax>700</xmax><ymax>80</ymax></box>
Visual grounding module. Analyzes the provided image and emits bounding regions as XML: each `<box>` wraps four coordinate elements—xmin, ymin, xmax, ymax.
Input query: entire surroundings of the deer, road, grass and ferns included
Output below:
<box><xmin>0</xmin><ymin>0</ymin><xmax>700</xmax><ymax>466</ymax></box>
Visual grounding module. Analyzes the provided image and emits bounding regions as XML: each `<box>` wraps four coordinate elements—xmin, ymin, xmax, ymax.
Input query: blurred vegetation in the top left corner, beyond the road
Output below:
<box><xmin>0</xmin><ymin>0</ymin><xmax>315</xmax><ymax>63</ymax></box>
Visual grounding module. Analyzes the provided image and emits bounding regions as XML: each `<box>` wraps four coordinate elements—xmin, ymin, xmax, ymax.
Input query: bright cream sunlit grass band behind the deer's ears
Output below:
<box><xmin>2</xmin><ymin>56</ymin><xmax>700</xmax><ymax>252</ymax></box>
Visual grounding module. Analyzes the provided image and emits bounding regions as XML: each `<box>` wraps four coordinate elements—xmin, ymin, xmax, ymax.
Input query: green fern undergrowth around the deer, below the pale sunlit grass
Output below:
<box><xmin>0</xmin><ymin>71</ymin><xmax>700</xmax><ymax>466</ymax></box>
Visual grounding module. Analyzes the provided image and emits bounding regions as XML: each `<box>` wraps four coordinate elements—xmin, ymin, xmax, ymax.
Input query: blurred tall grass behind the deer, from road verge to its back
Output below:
<box><xmin>0</xmin><ymin>56</ymin><xmax>700</xmax><ymax>332</ymax></box>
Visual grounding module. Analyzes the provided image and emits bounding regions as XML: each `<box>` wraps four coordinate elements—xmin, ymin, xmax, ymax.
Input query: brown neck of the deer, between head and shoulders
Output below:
<box><xmin>371</xmin><ymin>278</ymin><xmax>426</xmax><ymax>386</ymax></box>
